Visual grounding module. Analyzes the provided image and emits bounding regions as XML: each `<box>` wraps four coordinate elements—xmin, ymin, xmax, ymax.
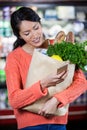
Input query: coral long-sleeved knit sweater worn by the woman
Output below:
<box><xmin>5</xmin><ymin>47</ymin><xmax>87</xmax><ymax>129</ymax></box>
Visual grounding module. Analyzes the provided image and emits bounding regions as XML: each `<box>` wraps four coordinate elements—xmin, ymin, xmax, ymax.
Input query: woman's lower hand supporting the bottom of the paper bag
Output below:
<box><xmin>38</xmin><ymin>97</ymin><xmax>59</xmax><ymax>118</ymax></box>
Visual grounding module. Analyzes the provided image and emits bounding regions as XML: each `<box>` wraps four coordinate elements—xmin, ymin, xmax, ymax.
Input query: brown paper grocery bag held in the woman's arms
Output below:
<box><xmin>23</xmin><ymin>49</ymin><xmax>75</xmax><ymax>116</ymax></box>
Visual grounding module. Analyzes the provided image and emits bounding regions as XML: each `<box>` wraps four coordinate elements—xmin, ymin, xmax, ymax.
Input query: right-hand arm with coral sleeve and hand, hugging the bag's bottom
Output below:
<box><xmin>39</xmin><ymin>70</ymin><xmax>87</xmax><ymax>117</ymax></box>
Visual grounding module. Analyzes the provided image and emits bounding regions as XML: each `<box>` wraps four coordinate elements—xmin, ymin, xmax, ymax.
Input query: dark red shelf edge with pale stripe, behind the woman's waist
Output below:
<box><xmin>0</xmin><ymin>105</ymin><xmax>87</xmax><ymax>126</ymax></box>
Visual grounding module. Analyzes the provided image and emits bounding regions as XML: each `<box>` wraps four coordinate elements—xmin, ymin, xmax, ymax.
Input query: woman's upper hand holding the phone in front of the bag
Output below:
<box><xmin>40</xmin><ymin>70</ymin><xmax>67</xmax><ymax>90</ymax></box>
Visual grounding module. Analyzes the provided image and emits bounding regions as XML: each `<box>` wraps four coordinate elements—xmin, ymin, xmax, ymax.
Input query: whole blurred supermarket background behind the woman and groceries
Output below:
<box><xmin>0</xmin><ymin>0</ymin><xmax>87</xmax><ymax>130</ymax></box>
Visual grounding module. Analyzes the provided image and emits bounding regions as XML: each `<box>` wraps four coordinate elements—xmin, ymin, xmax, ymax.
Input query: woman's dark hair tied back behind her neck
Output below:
<box><xmin>10</xmin><ymin>7</ymin><xmax>40</xmax><ymax>49</ymax></box>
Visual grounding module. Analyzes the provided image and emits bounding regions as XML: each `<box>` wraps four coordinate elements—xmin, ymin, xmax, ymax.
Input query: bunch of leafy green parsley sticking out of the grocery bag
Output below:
<box><xmin>47</xmin><ymin>41</ymin><xmax>87</xmax><ymax>72</ymax></box>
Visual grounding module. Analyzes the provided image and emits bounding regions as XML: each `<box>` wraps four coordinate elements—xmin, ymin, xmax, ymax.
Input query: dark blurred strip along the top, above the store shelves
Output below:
<box><xmin>0</xmin><ymin>0</ymin><xmax>87</xmax><ymax>7</ymax></box>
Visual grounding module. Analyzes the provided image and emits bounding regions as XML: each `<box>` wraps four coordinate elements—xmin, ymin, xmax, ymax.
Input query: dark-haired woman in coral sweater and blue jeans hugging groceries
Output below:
<box><xmin>5</xmin><ymin>7</ymin><xmax>87</xmax><ymax>130</ymax></box>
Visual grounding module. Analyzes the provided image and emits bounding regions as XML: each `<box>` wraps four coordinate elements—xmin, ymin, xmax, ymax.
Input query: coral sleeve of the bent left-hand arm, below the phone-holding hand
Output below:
<box><xmin>5</xmin><ymin>55</ymin><xmax>47</xmax><ymax>109</ymax></box>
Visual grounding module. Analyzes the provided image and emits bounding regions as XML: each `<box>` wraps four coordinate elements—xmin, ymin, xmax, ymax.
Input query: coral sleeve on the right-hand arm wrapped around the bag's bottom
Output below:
<box><xmin>54</xmin><ymin>70</ymin><xmax>87</xmax><ymax>107</ymax></box>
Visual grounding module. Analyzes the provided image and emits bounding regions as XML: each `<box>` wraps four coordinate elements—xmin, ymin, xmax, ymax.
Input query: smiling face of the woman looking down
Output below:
<box><xmin>19</xmin><ymin>20</ymin><xmax>43</xmax><ymax>47</ymax></box>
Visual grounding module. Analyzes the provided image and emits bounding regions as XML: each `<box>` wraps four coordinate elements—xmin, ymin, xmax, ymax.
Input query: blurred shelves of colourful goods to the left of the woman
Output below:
<box><xmin>0</xmin><ymin>7</ymin><xmax>16</xmax><ymax>109</ymax></box>
